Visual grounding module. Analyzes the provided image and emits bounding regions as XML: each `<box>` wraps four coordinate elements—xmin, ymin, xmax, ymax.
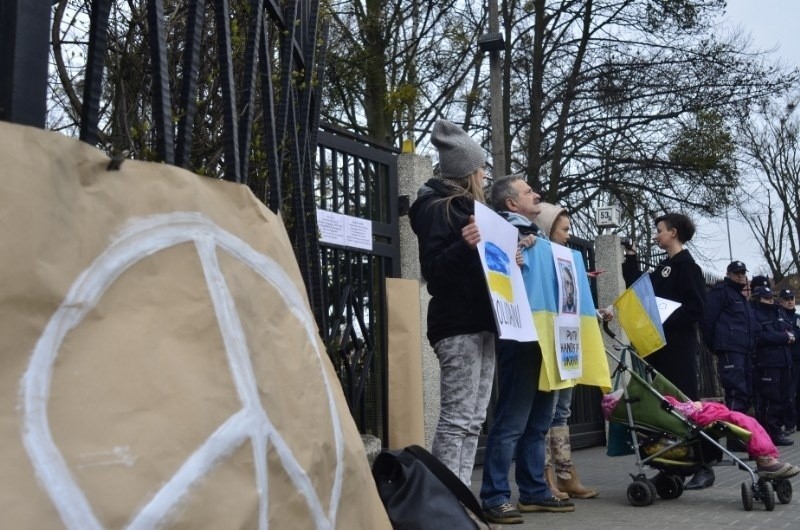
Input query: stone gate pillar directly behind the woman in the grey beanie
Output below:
<box><xmin>397</xmin><ymin>154</ymin><xmax>439</xmax><ymax>447</ymax></box>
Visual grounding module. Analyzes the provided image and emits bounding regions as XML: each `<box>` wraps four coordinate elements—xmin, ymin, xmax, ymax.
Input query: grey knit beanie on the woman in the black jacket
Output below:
<box><xmin>431</xmin><ymin>120</ymin><xmax>486</xmax><ymax>179</ymax></box>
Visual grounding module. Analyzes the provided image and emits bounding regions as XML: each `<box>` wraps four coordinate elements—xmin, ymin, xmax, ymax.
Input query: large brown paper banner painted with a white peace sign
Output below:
<box><xmin>0</xmin><ymin>123</ymin><xmax>390</xmax><ymax>530</ymax></box>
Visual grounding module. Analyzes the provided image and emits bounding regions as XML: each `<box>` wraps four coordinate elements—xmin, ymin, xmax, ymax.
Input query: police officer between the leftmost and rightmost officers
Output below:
<box><xmin>753</xmin><ymin>286</ymin><xmax>795</xmax><ymax>445</ymax></box>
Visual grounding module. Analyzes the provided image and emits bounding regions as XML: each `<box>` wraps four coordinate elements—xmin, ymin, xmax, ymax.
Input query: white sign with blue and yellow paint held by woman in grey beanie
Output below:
<box><xmin>475</xmin><ymin>202</ymin><xmax>538</xmax><ymax>342</ymax></box>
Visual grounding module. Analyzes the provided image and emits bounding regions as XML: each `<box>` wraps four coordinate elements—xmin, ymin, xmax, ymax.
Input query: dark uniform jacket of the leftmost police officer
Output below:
<box><xmin>700</xmin><ymin>278</ymin><xmax>760</xmax><ymax>355</ymax></box>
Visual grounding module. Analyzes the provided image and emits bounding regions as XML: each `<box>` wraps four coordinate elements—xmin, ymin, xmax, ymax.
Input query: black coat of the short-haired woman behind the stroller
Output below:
<box><xmin>622</xmin><ymin>250</ymin><xmax>706</xmax><ymax>400</ymax></box>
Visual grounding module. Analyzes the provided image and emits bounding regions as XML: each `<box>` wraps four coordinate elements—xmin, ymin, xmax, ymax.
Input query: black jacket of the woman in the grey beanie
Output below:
<box><xmin>409</xmin><ymin>178</ymin><xmax>497</xmax><ymax>345</ymax></box>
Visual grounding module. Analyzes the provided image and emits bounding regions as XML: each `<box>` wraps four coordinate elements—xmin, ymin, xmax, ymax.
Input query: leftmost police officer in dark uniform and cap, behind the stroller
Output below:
<box><xmin>700</xmin><ymin>261</ymin><xmax>759</xmax><ymax>414</ymax></box>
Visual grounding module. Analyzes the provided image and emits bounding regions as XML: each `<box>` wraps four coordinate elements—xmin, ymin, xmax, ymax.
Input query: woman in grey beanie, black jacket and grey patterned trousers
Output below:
<box><xmin>409</xmin><ymin>120</ymin><xmax>497</xmax><ymax>486</ymax></box>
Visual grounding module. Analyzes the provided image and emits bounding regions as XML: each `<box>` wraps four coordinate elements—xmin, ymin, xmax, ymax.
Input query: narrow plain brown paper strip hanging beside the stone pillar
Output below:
<box><xmin>386</xmin><ymin>278</ymin><xmax>425</xmax><ymax>449</ymax></box>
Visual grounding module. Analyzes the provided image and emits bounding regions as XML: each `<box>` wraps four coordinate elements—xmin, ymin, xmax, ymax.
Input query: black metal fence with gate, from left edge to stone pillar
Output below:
<box><xmin>0</xmin><ymin>0</ymin><xmax>399</xmax><ymax>437</ymax></box>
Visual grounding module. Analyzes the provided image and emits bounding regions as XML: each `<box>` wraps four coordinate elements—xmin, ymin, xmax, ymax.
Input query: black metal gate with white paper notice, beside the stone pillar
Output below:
<box><xmin>317</xmin><ymin>125</ymin><xmax>400</xmax><ymax>440</ymax></box>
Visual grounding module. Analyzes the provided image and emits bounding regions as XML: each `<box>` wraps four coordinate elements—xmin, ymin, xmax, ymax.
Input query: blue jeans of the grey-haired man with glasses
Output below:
<box><xmin>480</xmin><ymin>340</ymin><xmax>555</xmax><ymax>509</ymax></box>
